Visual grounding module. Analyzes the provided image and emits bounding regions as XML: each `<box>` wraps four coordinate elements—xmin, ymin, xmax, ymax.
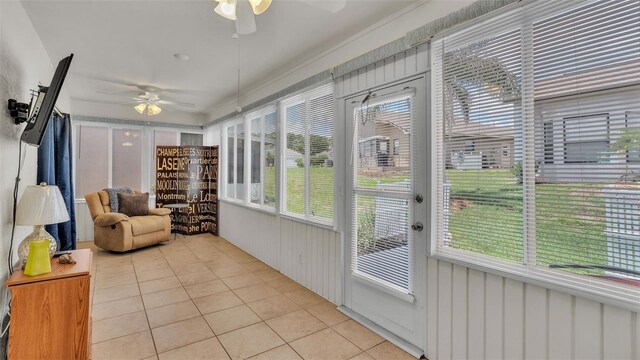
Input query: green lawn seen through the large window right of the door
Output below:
<box><xmin>447</xmin><ymin>170</ymin><xmax>607</xmax><ymax>272</ymax></box>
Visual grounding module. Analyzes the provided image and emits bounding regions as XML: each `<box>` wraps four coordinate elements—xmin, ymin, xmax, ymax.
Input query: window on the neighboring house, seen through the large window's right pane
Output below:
<box><xmin>563</xmin><ymin>114</ymin><xmax>609</xmax><ymax>164</ymax></box>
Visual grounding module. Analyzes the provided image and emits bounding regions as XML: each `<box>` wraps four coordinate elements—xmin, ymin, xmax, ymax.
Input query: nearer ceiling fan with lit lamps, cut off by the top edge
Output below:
<box><xmin>214</xmin><ymin>0</ymin><xmax>346</xmax><ymax>35</ymax></box>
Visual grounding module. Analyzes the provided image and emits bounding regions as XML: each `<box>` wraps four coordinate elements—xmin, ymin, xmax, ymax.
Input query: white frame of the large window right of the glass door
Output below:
<box><xmin>427</xmin><ymin>3</ymin><xmax>640</xmax><ymax>311</ymax></box>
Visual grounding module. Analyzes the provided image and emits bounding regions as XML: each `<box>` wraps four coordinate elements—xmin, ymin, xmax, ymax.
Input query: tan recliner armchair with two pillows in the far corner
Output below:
<box><xmin>84</xmin><ymin>191</ymin><xmax>171</xmax><ymax>252</ymax></box>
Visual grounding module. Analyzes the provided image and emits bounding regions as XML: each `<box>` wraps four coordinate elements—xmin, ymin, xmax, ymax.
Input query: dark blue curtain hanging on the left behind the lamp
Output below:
<box><xmin>38</xmin><ymin>114</ymin><xmax>76</xmax><ymax>251</ymax></box>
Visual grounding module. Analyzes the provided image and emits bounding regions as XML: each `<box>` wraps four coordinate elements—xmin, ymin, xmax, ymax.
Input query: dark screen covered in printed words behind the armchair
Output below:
<box><xmin>155</xmin><ymin>146</ymin><xmax>218</xmax><ymax>235</ymax></box>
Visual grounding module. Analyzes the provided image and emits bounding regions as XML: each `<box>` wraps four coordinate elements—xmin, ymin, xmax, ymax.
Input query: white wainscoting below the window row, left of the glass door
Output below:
<box><xmin>219</xmin><ymin>201</ymin><xmax>342</xmax><ymax>305</ymax></box>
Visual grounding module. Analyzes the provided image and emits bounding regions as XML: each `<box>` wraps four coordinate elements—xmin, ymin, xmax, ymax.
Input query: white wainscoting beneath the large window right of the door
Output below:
<box><xmin>426</xmin><ymin>258</ymin><xmax>640</xmax><ymax>359</ymax></box>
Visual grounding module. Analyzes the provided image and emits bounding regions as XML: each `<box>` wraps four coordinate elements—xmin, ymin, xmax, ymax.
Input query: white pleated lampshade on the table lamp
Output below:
<box><xmin>15</xmin><ymin>183</ymin><xmax>69</xmax><ymax>225</ymax></box>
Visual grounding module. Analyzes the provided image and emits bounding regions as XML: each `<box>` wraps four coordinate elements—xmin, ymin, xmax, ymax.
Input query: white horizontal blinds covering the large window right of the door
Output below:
<box><xmin>432</xmin><ymin>0</ymin><xmax>640</xmax><ymax>302</ymax></box>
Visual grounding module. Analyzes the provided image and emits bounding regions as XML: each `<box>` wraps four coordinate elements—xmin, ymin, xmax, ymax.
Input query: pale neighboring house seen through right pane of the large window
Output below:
<box><xmin>535</xmin><ymin>63</ymin><xmax>640</xmax><ymax>183</ymax></box>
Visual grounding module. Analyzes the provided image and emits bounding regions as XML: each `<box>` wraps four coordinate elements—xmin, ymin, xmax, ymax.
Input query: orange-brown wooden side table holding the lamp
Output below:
<box><xmin>7</xmin><ymin>249</ymin><xmax>92</xmax><ymax>360</ymax></box>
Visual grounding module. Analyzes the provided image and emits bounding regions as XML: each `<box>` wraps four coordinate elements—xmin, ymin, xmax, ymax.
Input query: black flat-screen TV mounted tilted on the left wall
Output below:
<box><xmin>21</xmin><ymin>54</ymin><xmax>73</xmax><ymax>146</ymax></box>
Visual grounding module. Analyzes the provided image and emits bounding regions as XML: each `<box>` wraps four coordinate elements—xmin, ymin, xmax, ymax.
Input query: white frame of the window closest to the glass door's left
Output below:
<box><xmin>279</xmin><ymin>82</ymin><xmax>337</xmax><ymax>229</ymax></box>
